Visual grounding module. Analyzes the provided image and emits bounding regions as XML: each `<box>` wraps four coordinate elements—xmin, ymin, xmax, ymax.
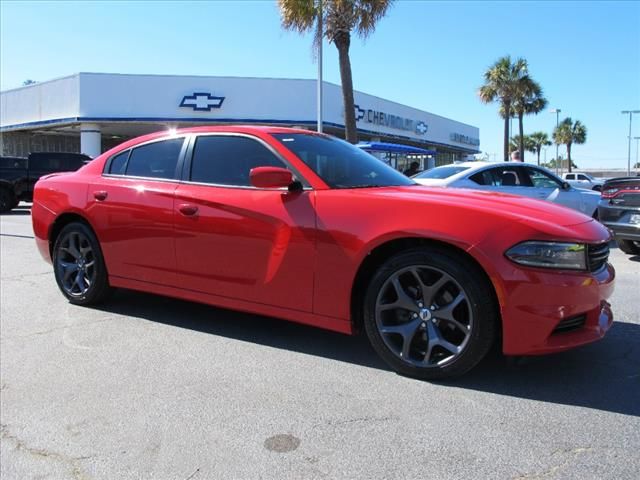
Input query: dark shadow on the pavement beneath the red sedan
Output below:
<box><xmin>92</xmin><ymin>290</ymin><xmax>640</xmax><ymax>416</ymax></box>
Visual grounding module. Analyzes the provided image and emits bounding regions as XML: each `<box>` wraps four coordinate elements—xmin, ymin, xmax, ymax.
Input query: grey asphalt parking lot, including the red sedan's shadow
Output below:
<box><xmin>0</xmin><ymin>207</ymin><xmax>640</xmax><ymax>480</ymax></box>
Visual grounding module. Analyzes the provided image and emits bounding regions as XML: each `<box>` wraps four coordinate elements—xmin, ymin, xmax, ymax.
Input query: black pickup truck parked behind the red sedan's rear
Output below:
<box><xmin>0</xmin><ymin>152</ymin><xmax>91</xmax><ymax>213</ymax></box>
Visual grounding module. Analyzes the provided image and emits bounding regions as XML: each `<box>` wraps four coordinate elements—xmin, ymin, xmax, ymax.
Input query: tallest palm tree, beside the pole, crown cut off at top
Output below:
<box><xmin>278</xmin><ymin>0</ymin><xmax>393</xmax><ymax>143</ymax></box>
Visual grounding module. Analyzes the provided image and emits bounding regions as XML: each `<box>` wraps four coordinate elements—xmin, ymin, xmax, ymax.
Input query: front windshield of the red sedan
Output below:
<box><xmin>273</xmin><ymin>133</ymin><xmax>415</xmax><ymax>188</ymax></box>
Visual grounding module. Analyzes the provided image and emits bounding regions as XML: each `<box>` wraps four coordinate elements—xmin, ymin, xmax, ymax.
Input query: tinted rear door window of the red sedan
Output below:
<box><xmin>126</xmin><ymin>138</ymin><xmax>184</xmax><ymax>178</ymax></box>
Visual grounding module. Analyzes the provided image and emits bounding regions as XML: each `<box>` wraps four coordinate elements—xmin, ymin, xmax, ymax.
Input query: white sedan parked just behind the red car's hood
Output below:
<box><xmin>413</xmin><ymin>162</ymin><xmax>600</xmax><ymax>219</ymax></box>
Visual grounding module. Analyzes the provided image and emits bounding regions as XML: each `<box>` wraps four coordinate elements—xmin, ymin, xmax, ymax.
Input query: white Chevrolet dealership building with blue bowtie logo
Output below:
<box><xmin>0</xmin><ymin>73</ymin><xmax>480</xmax><ymax>165</ymax></box>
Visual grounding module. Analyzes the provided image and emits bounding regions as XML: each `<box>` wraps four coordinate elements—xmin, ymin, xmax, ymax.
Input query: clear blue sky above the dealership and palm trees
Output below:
<box><xmin>0</xmin><ymin>0</ymin><xmax>640</xmax><ymax>168</ymax></box>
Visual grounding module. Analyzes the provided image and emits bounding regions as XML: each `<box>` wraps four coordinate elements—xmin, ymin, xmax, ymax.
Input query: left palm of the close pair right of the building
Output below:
<box><xmin>478</xmin><ymin>55</ymin><xmax>528</xmax><ymax>162</ymax></box>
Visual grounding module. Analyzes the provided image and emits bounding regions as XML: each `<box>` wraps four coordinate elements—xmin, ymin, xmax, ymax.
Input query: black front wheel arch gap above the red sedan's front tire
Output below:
<box><xmin>350</xmin><ymin>237</ymin><xmax>502</xmax><ymax>336</ymax></box>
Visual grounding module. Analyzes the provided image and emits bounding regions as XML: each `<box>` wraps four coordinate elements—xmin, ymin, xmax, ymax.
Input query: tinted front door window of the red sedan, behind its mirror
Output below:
<box><xmin>190</xmin><ymin>135</ymin><xmax>286</xmax><ymax>186</ymax></box>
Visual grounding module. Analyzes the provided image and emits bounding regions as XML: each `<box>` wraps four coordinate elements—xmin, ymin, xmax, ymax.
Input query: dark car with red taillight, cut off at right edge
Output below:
<box><xmin>598</xmin><ymin>177</ymin><xmax>640</xmax><ymax>255</ymax></box>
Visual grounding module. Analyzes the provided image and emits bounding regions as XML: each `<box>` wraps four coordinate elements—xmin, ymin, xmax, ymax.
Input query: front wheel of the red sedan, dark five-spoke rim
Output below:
<box><xmin>363</xmin><ymin>247</ymin><xmax>499</xmax><ymax>380</ymax></box>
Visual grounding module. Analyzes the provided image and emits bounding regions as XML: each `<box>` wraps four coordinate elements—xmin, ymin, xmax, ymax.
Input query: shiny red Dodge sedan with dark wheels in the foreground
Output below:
<box><xmin>32</xmin><ymin>127</ymin><xmax>615</xmax><ymax>379</ymax></box>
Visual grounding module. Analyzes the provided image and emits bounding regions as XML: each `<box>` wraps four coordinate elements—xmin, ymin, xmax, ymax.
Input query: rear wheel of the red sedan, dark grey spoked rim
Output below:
<box><xmin>53</xmin><ymin>222</ymin><xmax>112</xmax><ymax>305</ymax></box>
